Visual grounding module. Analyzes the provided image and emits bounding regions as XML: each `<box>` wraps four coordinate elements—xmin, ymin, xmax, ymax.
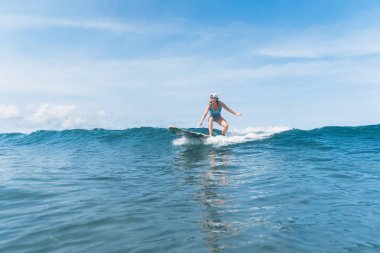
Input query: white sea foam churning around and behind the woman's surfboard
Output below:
<box><xmin>173</xmin><ymin>126</ymin><xmax>291</xmax><ymax>146</ymax></box>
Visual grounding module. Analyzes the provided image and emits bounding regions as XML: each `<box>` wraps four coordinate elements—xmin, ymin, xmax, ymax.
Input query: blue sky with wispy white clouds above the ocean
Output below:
<box><xmin>0</xmin><ymin>0</ymin><xmax>380</xmax><ymax>132</ymax></box>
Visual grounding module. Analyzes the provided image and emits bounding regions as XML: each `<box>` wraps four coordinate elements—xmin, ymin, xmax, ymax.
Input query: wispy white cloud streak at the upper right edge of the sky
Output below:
<box><xmin>251</xmin><ymin>20</ymin><xmax>380</xmax><ymax>59</ymax></box>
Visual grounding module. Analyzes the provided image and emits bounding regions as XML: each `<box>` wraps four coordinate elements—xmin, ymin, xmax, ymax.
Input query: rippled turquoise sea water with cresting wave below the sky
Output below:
<box><xmin>0</xmin><ymin>126</ymin><xmax>380</xmax><ymax>253</ymax></box>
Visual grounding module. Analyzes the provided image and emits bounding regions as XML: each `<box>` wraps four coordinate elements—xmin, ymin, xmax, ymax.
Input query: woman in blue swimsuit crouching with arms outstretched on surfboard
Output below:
<box><xmin>198</xmin><ymin>93</ymin><xmax>242</xmax><ymax>137</ymax></box>
